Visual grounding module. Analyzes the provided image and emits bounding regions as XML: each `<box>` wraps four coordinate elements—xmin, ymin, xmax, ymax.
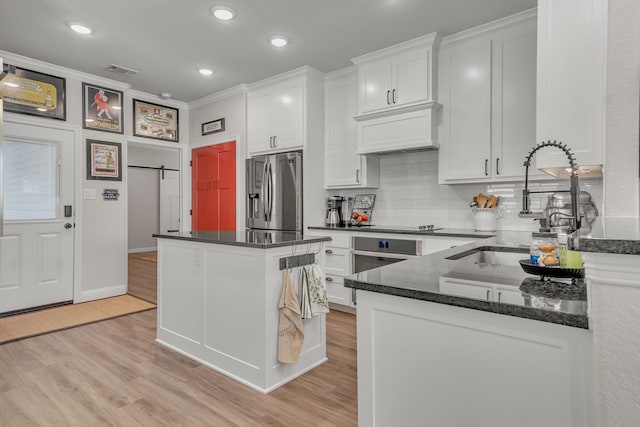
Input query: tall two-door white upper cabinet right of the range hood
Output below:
<box><xmin>439</xmin><ymin>10</ymin><xmax>543</xmax><ymax>183</ymax></box>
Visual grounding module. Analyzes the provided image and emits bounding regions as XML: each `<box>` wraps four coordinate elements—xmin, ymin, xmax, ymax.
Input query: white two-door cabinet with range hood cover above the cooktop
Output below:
<box><xmin>351</xmin><ymin>33</ymin><xmax>440</xmax><ymax>154</ymax></box>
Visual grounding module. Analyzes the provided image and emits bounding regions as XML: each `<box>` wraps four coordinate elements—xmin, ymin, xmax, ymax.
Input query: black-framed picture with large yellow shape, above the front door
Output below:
<box><xmin>0</xmin><ymin>64</ymin><xmax>67</xmax><ymax>120</ymax></box>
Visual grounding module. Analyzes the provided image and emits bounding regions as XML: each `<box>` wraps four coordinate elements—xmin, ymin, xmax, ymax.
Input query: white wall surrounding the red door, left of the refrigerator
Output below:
<box><xmin>185</xmin><ymin>85</ymin><xmax>247</xmax><ymax>230</ymax></box>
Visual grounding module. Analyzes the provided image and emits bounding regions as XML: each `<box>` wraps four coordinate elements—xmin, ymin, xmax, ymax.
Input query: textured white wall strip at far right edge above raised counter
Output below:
<box><xmin>604</xmin><ymin>0</ymin><xmax>640</xmax><ymax>217</ymax></box>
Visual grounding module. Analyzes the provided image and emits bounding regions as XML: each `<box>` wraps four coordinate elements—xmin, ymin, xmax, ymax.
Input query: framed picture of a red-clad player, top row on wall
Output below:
<box><xmin>82</xmin><ymin>83</ymin><xmax>123</xmax><ymax>133</ymax></box>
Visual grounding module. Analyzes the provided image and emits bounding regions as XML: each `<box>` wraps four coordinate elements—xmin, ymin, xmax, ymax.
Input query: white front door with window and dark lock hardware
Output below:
<box><xmin>0</xmin><ymin>122</ymin><xmax>75</xmax><ymax>313</ymax></box>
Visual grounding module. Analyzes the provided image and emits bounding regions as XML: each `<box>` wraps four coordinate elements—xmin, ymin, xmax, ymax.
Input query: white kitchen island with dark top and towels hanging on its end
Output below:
<box><xmin>154</xmin><ymin>230</ymin><xmax>330</xmax><ymax>393</ymax></box>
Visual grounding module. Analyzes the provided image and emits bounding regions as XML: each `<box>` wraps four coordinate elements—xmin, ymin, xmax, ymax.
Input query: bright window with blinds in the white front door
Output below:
<box><xmin>4</xmin><ymin>140</ymin><xmax>58</xmax><ymax>221</ymax></box>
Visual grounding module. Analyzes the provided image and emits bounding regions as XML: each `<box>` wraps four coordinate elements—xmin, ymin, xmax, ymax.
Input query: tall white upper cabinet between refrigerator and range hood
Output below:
<box><xmin>324</xmin><ymin>68</ymin><xmax>380</xmax><ymax>189</ymax></box>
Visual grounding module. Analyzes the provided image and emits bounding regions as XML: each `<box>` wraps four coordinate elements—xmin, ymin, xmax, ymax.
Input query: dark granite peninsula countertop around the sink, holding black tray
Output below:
<box><xmin>344</xmin><ymin>236</ymin><xmax>589</xmax><ymax>329</ymax></box>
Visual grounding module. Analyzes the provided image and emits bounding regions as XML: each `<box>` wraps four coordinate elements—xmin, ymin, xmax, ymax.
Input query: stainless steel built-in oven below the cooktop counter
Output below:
<box><xmin>351</xmin><ymin>236</ymin><xmax>422</xmax><ymax>273</ymax></box>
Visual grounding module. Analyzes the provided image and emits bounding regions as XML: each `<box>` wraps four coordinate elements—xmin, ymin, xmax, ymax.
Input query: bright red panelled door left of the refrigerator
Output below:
<box><xmin>191</xmin><ymin>141</ymin><xmax>236</xmax><ymax>231</ymax></box>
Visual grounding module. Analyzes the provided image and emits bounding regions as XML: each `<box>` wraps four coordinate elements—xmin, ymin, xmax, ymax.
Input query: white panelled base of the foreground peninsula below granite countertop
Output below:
<box><xmin>357</xmin><ymin>290</ymin><xmax>597</xmax><ymax>427</ymax></box>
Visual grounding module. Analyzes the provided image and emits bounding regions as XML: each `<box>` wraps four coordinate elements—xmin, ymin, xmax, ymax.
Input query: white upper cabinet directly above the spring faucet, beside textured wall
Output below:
<box><xmin>536</xmin><ymin>0</ymin><xmax>607</xmax><ymax>176</ymax></box>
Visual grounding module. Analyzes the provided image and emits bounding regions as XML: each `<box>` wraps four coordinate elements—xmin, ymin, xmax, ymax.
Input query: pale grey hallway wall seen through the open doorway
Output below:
<box><xmin>127</xmin><ymin>143</ymin><xmax>180</xmax><ymax>252</ymax></box>
